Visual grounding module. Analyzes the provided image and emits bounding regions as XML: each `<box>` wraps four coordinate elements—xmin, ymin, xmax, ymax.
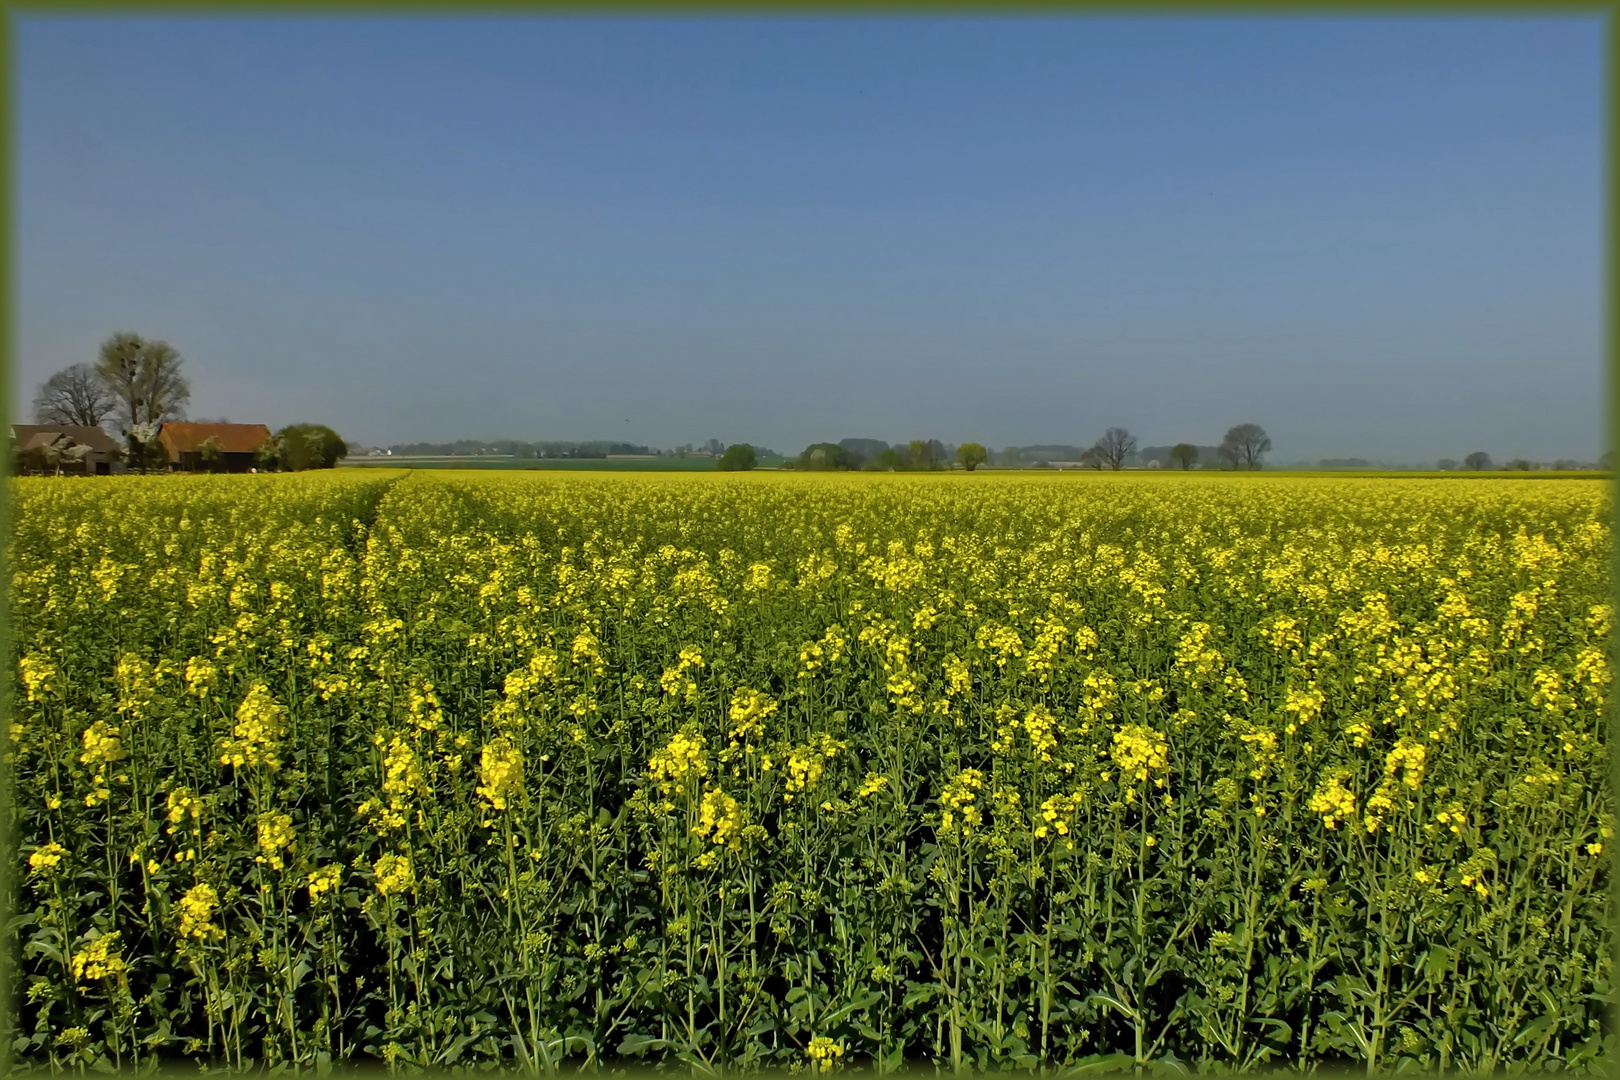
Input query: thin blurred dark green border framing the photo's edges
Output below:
<box><xmin>0</xmin><ymin>10</ymin><xmax>1620</xmax><ymax>1080</ymax></box>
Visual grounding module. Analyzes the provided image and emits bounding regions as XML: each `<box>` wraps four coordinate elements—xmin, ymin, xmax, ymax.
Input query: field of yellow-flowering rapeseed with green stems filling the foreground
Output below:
<box><xmin>10</xmin><ymin>471</ymin><xmax>1617</xmax><ymax>1074</ymax></box>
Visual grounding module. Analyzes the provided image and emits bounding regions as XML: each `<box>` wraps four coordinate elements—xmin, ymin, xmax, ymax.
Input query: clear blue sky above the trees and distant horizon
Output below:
<box><xmin>15</xmin><ymin>18</ymin><xmax>1607</xmax><ymax>461</ymax></box>
